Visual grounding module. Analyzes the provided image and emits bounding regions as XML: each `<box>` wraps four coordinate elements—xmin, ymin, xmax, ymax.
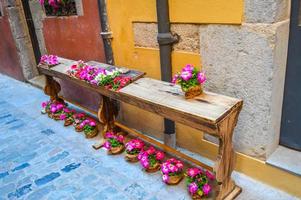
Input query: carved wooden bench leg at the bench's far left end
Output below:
<box><xmin>44</xmin><ymin>75</ymin><xmax>64</xmax><ymax>103</ymax></box>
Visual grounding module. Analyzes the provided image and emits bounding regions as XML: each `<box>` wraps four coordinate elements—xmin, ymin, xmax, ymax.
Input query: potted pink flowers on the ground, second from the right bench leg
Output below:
<box><xmin>161</xmin><ymin>158</ymin><xmax>184</xmax><ymax>185</ymax></box>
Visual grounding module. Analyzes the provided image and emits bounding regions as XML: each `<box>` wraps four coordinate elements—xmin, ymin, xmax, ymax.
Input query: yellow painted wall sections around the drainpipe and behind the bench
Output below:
<box><xmin>107</xmin><ymin>0</ymin><xmax>301</xmax><ymax>196</ymax></box>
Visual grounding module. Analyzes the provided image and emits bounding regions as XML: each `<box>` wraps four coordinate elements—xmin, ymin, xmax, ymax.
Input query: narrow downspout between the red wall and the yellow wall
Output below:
<box><xmin>98</xmin><ymin>0</ymin><xmax>114</xmax><ymax>65</ymax></box>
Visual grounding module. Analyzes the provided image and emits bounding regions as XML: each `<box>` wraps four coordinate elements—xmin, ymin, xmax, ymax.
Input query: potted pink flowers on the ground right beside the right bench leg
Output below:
<box><xmin>186</xmin><ymin>168</ymin><xmax>215</xmax><ymax>199</ymax></box>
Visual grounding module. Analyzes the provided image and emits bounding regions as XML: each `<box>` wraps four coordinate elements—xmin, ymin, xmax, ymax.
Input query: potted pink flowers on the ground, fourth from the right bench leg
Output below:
<box><xmin>125</xmin><ymin>139</ymin><xmax>144</xmax><ymax>162</ymax></box>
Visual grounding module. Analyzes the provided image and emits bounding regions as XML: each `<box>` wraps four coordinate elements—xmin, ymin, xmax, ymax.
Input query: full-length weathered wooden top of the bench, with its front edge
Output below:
<box><xmin>39</xmin><ymin>60</ymin><xmax>242</xmax><ymax>135</ymax></box>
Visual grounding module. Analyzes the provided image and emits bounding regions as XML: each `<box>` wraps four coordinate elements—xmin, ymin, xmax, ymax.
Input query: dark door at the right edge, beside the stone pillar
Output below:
<box><xmin>280</xmin><ymin>0</ymin><xmax>301</xmax><ymax>151</ymax></box>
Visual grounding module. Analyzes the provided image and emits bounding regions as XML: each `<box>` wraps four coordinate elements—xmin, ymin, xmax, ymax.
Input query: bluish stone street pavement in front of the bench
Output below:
<box><xmin>0</xmin><ymin>75</ymin><xmax>297</xmax><ymax>200</ymax></box>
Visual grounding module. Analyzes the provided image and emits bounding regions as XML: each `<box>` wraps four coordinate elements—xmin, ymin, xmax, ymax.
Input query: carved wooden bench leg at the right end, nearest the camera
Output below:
<box><xmin>214</xmin><ymin>109</ymin><xmax>241</xmax><ymax>199</ymax></box>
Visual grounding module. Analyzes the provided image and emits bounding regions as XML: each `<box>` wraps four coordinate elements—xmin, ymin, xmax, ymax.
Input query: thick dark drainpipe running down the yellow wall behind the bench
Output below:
<box><xmin>156</xmin><ymin>0</ymin><xmax>178</xmax><ymax>147</ymax></box>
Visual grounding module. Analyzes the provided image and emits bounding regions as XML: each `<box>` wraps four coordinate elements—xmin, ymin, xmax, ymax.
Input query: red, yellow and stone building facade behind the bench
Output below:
<box><xmin>0</xmin><ymin>0</ymin><xmax>301</xmax><ymax>195</ymax></box>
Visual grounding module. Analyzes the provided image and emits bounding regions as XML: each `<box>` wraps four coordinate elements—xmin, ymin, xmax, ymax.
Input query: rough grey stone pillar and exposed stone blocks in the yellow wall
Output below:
<box><xmin>133</xmin><ymin>0</ymin><xmax>290</xmax><ymax>160</ymax></box>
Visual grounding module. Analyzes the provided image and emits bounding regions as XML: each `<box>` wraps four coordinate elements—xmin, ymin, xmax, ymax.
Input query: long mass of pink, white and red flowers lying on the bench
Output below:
<box><xmin>67</xmin><ymin>61</ymin><xmax>131</xmax><ymax>91</ymax></box>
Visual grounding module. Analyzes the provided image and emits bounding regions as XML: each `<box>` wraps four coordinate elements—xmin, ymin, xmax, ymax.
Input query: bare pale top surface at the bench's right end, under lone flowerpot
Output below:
<box><xmin>120</xmin><ymin>78</ymin><xmax>241</xmax><ymax>123</ymax></box>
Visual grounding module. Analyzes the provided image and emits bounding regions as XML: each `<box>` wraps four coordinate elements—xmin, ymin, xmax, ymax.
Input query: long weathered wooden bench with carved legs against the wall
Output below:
<box><xmin>38</xmin><ymin>59</ymin><xmax>243</xmax><ymax>199</ymax></box>
